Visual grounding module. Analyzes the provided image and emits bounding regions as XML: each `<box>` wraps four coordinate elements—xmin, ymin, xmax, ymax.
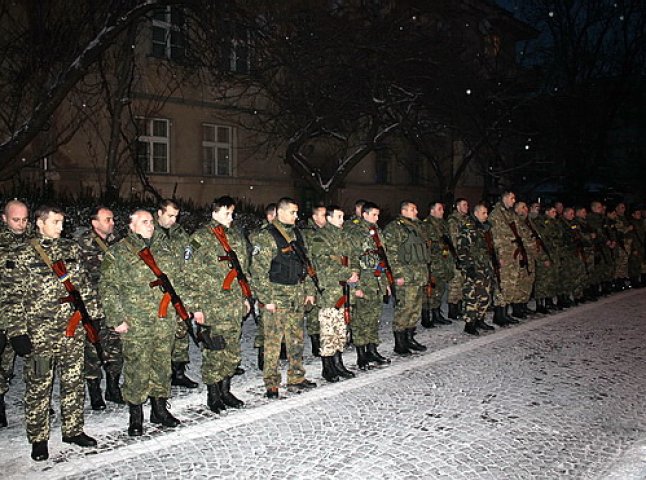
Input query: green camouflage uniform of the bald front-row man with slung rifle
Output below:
<box><xmin>99</xmin><ymin>232</ymin><xmax>181</xmax><ymax>405</ymax></box>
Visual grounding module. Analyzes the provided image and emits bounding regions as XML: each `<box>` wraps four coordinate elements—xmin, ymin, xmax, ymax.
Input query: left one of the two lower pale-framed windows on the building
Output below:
<box><xmin>137</xmin><ymin>118</ymin><xmax>170</xmax><ymax>173</ymax></box>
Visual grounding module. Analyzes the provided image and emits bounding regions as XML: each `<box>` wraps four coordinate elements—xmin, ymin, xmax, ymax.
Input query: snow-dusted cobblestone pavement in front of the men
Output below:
<box><xmin>0</xmin><ymin>290</ymin><xmax>646</xmax><ymax>479</ymax></box>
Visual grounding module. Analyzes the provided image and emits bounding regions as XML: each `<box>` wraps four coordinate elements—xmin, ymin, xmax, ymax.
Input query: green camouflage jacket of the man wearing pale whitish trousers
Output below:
<box><xmin>308</xmin><ymin>223</ymin><xmax>359</xmax><ymax>307</ymax></box>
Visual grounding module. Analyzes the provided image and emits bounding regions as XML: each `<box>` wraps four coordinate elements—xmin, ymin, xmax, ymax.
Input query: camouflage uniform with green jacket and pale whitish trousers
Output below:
<box><xmin>308</xmin><ymin>223</ymin><xmax>352</xmax><ymax>357</ymax></box>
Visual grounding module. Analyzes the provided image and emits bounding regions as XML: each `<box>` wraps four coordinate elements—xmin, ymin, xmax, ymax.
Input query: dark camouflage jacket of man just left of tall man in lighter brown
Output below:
<box><xmin>456</xmin><ymin>216</ymin><xmax>493</xmax><ymax>278</ymax></box>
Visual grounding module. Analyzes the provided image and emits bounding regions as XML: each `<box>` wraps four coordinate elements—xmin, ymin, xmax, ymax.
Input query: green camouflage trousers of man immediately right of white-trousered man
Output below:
<box><xmin>350</xmin><ymin>276</ymin><xmax>386</xmax><ymax>347</ymax></box>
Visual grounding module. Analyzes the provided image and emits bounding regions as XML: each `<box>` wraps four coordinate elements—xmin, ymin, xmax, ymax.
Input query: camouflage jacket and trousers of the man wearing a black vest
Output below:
<box><xmin>251</xmin><ymin>220</ymin><xmax>313</xmax><ymax>390</ymax></box>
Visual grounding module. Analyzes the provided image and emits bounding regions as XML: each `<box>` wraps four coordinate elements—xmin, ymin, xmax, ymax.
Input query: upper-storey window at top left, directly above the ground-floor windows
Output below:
<box><xmin>152</xmin><ymin>6</ymin><xmax>186</xmax><ymax>60</ymax></box>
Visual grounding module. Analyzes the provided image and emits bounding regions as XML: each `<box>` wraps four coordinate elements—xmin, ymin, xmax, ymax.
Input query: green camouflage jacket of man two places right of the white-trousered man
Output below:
<box><xmin>382</xmin><ymin>217</ymin><xmax>431</xmax><ymax>286</ymax></box>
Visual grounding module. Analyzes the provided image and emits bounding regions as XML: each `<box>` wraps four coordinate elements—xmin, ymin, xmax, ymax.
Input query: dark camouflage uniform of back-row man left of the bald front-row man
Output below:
<box><xmin>78</xmin><ymin>229</ymin><xmax>123</xmax><ymax>380</ymax></box>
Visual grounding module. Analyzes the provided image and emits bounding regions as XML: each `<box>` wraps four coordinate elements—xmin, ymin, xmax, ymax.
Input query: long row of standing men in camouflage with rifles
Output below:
<box><xmin>0</xmin><ymin>192</ymin><xmax>646</xmax><ymax>460</ymax></box>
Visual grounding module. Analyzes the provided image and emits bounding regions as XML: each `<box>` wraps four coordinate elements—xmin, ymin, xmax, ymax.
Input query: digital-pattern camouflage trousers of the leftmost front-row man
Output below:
<box><xmin>23</xmin><ymin>337</ymin><xmax>85</xmax><ymax>443</ymax></box>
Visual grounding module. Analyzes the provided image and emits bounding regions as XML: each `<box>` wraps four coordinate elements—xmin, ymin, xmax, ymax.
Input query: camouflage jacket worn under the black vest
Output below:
<box><xmin>251</xmin><ymin>220</ymin><xmax>316</xmax><ymax>304</ymax></box>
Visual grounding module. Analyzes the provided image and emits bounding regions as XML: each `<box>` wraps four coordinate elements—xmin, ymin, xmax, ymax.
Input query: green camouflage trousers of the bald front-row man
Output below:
<box><xmin>121</xmin><ymin>317</ymin><xmax>176</xmax><ymax>405</ymax></box>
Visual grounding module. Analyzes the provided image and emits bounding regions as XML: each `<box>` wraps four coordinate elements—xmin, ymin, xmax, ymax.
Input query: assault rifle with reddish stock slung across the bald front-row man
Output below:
<box><xmin>137</xmin><ymin>247</ymin><xmax>224</xmax><ymax>350</ymax></box>
